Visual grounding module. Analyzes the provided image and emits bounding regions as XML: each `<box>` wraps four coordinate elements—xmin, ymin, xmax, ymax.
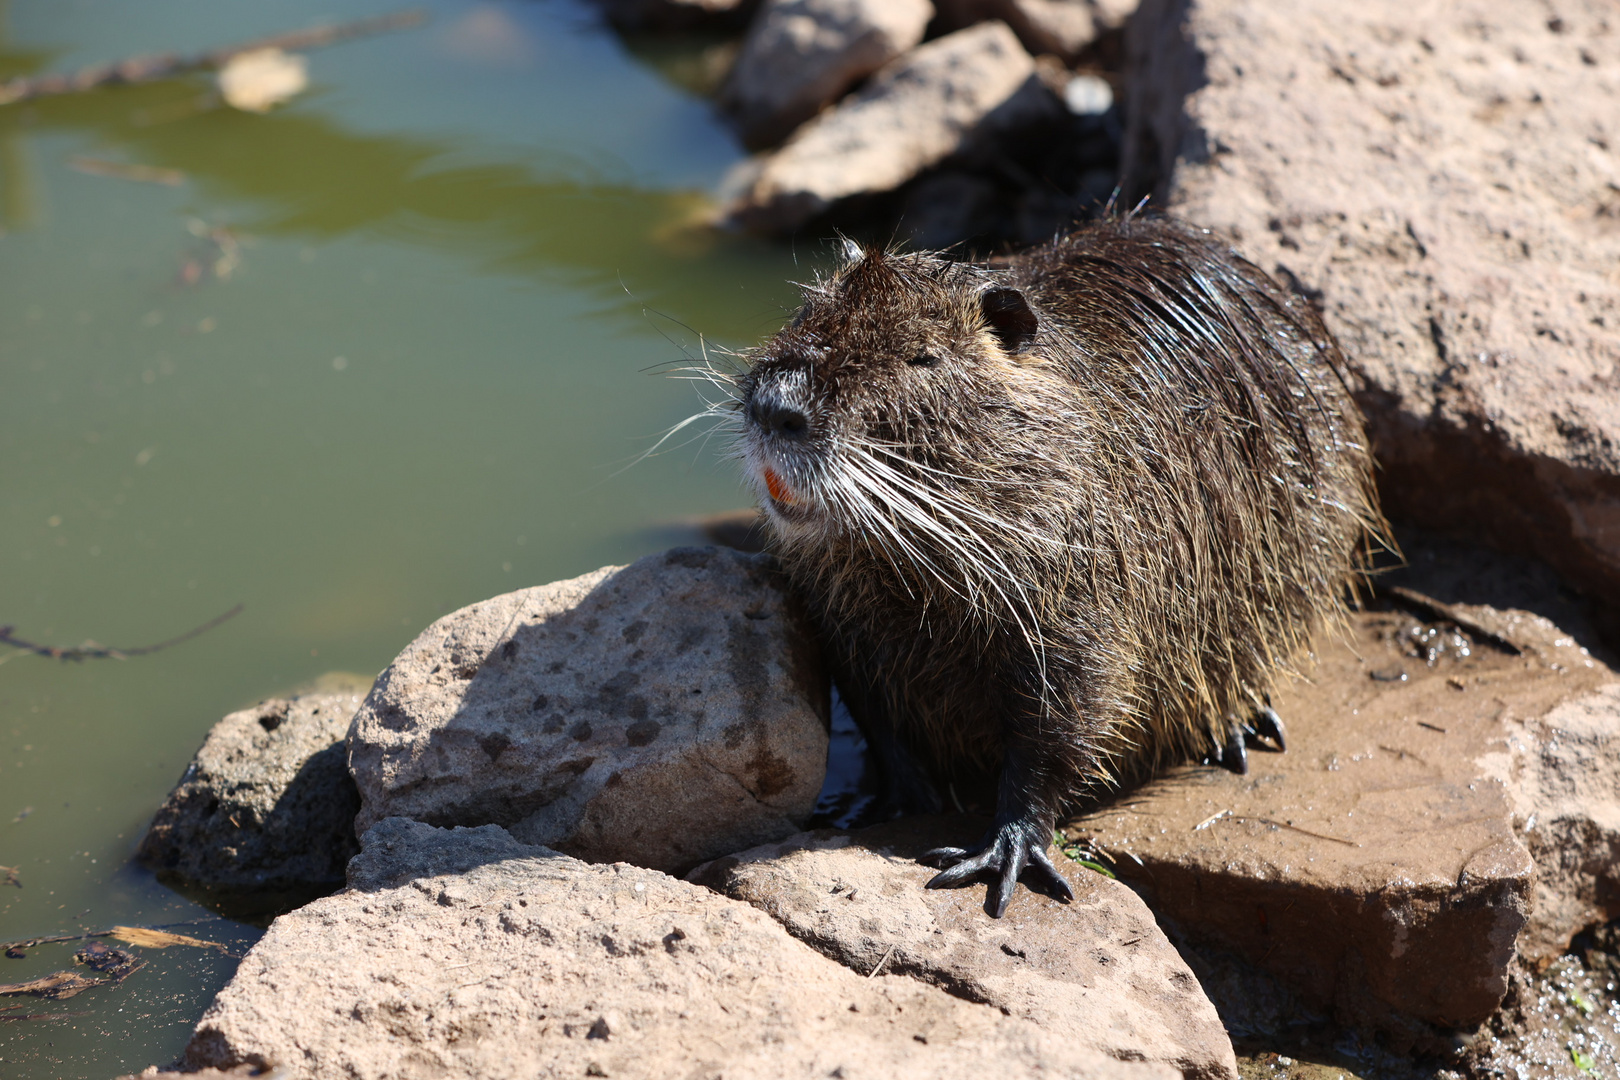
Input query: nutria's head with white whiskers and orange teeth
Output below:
<box><xmin>737</xmin><ymin>244</ymin><xmax>1040</xmax><ymax>549</ymax></box>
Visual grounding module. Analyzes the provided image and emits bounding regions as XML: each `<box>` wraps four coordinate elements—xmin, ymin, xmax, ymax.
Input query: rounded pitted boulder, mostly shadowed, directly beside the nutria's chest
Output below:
<box><xmin>348</xmin><ymin>547</ymin><xmax>828</xmax><ymax>870</ymax></box>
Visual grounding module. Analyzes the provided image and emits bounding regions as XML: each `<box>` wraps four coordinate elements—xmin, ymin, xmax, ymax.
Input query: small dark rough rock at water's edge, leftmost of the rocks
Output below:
<box><xmin>139</xmin><ymin>693</ymin><xmax>360</xmax><ymax>910</ymax></box>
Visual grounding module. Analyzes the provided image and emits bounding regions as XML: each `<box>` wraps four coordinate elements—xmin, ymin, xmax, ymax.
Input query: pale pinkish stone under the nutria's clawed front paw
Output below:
<box><xmin>689</xmin><ymin>818</ymin><xmax>1238</xmax><ymax>1080</ymax></box>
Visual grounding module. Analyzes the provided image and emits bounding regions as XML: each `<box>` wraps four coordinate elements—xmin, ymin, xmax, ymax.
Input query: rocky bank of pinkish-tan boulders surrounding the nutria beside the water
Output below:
<box><xmin>126</xmin><ymin>0</ymin><xmax>1620</xmax><ymax>1078</ymax></box>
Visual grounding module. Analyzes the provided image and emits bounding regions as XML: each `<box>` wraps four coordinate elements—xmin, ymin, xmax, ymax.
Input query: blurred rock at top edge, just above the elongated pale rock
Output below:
<box><xmin>721</xmin><ymin>0</ymin><xmax>933</xmax><ymax>147</ymax></box>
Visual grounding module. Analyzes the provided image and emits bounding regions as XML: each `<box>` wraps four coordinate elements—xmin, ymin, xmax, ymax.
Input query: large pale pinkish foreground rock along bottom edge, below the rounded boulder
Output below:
<box><xmin>186</xmin><ymin>819</ymin><xmax>1175</xmax><ymax>1080</ymax></box>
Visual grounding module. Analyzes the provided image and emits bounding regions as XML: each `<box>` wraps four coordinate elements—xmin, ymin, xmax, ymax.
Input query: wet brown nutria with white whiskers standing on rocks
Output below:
<box><xmin>729</xmin><ymin>217</ymin><xmax>1385</xmax><ymax>916</ymax></box>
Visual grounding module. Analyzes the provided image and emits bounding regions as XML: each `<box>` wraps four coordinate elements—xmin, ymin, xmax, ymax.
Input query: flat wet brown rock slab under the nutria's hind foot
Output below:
<box><xmin>1066</xmin><ymin>594</ymin><xmax>1620</xmax><ymax>1043</ymax></box>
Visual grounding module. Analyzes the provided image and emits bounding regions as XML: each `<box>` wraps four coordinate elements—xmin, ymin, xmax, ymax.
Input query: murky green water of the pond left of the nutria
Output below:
<box><xmin>0</xmin><ymin>0</ymin><xmax>802</xmax><ymax>1078</ymax></box>
